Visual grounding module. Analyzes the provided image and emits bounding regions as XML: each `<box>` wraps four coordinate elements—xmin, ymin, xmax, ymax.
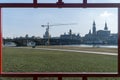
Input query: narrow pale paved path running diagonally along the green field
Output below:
<box><xmin>16</xmin><ymin>47</ymin><xmax>118</xmax><ymax>56</ymax></box>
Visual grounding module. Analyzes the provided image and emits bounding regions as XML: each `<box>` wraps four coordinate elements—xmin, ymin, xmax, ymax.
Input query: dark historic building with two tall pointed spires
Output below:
<box><xmin>83</xmin><ymin>21</ymin><xmax>111</xmax><ymax>44</ymax></box>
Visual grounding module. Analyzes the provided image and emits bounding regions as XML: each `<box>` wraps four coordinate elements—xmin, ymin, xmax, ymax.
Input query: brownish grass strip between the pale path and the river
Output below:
<box><xmin>37</xmin><ymin>45</ymin><xmax>118</xmax><ymax>53</ymax></box>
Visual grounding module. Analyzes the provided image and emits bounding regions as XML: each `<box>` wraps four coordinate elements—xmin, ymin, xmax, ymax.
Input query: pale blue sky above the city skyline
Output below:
<box><xmin>0</xmin><ymin>0</ymin><xmax>120</xmax><ymax>38</ymax></box>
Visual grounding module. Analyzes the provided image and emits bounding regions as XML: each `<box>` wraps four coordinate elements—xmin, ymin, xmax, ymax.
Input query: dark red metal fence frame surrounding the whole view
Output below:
<box><xmin>0</xmin><ymin>0</ymin><xmax>120</xmax><ymax>80</ymax></box>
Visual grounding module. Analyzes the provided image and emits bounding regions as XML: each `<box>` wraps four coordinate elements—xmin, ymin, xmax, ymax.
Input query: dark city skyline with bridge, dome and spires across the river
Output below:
<box><xmin>4</xmin><ymin>21</ymin><xmax>118</xmax><ymax>46</ymax></box>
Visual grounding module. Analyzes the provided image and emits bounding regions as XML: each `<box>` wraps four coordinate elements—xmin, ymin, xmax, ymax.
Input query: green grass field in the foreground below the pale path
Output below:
<box><xmin>3</xmin><ymin>47</ymin><xmax>120</xmax><ymax>80</ymax></box>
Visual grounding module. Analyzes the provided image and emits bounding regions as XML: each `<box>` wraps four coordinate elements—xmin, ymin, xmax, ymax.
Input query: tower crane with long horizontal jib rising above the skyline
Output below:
<box><xmin>41</xmin><ymin>23</ymin><xmax>76</xmax><ymax>45</ymax></box>
